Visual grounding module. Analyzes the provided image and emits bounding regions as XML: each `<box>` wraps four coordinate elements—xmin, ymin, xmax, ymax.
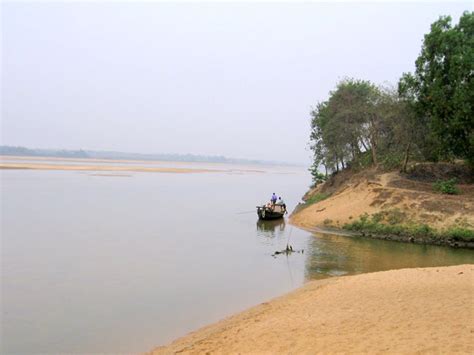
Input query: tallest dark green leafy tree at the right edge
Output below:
<box><xmin>399</xmin><ymin>12</ymin><xmax>474</xmax><ymax>161</ymax></box>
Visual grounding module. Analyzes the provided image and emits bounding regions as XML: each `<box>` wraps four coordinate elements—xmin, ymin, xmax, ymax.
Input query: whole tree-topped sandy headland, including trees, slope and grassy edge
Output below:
<box><xmin>292</xmin><ymin>12</ymin><xmax>474</xmax><ymax>247</ymax></box>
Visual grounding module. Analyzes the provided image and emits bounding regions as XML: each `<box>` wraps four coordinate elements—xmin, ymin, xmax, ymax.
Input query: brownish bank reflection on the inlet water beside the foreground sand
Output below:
<box><xmin>305</xmin><ymin>233</ymin><xmax>474</xmax><ymax>280</ymax></box>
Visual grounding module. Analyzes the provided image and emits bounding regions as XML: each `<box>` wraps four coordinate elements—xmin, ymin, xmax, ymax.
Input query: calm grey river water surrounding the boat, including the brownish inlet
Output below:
<box><xmin>1</xmin><ymin>167</ymin><xmax>474</xmax><ymax>354</ymax></box>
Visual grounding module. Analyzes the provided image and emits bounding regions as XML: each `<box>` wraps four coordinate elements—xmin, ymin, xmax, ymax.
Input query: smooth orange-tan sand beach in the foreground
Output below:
<box><xmin>152</xmin><ymin>265</ymin><xmax>474</xmax><ymax>354</ymax></box>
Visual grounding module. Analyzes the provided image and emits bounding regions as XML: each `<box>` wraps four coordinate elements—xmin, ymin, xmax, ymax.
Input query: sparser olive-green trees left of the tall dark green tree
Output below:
<box><xmin>310</xmin><ymin>79</ymin><xmax>419</xmax><ymax>177</ymax></box>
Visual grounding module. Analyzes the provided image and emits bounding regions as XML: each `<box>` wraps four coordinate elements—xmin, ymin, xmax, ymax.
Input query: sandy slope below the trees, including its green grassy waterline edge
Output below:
<box><xmin>290</xmin><ymin>169</ymin><xmax>474</xmax><ymax>249</ymax></box>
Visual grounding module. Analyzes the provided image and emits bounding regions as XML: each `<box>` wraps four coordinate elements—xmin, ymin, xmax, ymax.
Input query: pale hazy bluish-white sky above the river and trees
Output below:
<box><xmin>1</xmin><ymin>2</ymin><xmax>472</xmax><ymax>162</ymax></box>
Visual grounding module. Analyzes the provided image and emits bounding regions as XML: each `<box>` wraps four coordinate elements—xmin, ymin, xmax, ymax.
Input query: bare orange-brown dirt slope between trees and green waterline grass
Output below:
<box><xmin>290</xmin><ymin>170</ymin><xmax>474</xmax><ymax>238</ymax></box>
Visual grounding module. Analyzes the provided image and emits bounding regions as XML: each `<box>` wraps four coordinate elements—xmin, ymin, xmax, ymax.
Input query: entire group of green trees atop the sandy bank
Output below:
<box><xmin>310</xmin><ymin>12</ymin><xmax>474</xmax><ymax>182</ymax></box>
